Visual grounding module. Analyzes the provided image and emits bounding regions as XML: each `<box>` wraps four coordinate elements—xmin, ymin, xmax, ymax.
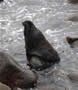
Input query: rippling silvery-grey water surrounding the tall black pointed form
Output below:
<box><xmin>0</xmin><ymin>0</ymin><xmax>78</xmax><ymax>90</ymax></box>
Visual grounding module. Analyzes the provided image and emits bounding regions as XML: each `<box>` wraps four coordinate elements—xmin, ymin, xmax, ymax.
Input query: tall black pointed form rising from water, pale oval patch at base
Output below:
<box><xmin>22</xmin><ymin>21</ymin><xmax>60</xmax><ymax>70</ymax></box>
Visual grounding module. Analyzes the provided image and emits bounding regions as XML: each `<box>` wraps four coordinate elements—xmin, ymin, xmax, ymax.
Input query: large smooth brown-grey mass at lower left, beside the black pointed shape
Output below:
<box><xmin>0</xmin><ymin>52</ymin><xmax>37</xmax><ymax>90</ymax></box>
